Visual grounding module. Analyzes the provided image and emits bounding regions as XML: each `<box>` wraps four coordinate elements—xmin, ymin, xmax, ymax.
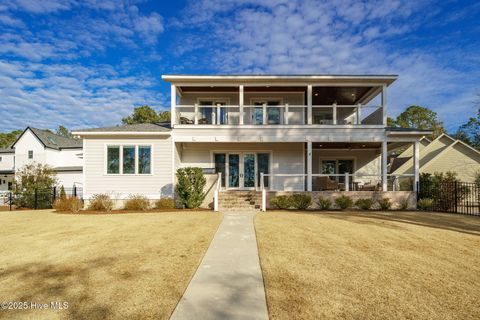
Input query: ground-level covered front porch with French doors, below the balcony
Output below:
<box><xmin>175</xmin><ymin>141</ymin><xmax>418</xmax><ymax>210</ymax></box>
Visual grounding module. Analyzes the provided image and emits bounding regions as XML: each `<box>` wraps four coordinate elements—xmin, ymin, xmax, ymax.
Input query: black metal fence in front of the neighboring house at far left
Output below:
<box><xmin>0</xmin><ymin>187</ymin><xmax>83</xmax><ymax>211</ymax></box>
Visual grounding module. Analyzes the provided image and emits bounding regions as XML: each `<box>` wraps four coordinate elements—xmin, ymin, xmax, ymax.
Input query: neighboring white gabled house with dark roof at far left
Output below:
<box><xmin>0</xmin><ymin>127</ymin><xmax>83</xmax><ymax>190</ymax></box>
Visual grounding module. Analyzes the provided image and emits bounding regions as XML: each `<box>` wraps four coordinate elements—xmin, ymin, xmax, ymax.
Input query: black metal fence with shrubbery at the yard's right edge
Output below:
<box><xmin>417</xmin><ymin>181</ymin><xmax>480</xmax><ymax>215</ymax></box>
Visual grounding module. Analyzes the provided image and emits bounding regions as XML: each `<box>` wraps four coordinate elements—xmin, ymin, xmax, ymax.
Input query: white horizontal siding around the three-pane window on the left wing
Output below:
<box><xmin>84</xmin><ymin>137</ymin><xmax>173</xmax><ymax>199</ymax></box>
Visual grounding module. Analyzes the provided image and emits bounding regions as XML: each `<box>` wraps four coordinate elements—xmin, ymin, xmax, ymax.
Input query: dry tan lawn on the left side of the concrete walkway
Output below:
<box><xmin>0</xmin><ymin>210</ymin><xmax>221</xmax><ymax>319</ymax></box>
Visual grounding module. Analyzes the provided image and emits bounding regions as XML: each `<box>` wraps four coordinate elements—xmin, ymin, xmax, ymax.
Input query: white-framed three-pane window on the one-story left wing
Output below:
<box><xmin>106</xmin><ymin>145</ymin><xmax>152</xmax><ymax>174</ymax></box>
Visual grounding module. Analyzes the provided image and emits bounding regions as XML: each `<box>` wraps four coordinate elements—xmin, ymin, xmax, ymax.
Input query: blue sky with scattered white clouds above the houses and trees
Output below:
<box><xmin>0</xmin><ymin>0</ymin><xmax>480</xmax><ymax>132</ymax></box>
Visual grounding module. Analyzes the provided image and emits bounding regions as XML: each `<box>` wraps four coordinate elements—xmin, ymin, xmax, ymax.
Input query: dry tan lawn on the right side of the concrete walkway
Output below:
<box><xmin>255</xmin><ymin>212</ymin><xmax>480</xmax><ymax>319</ymax></box>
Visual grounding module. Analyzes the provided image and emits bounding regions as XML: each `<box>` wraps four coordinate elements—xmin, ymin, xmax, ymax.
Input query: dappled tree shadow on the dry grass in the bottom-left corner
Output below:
<box><xmin>0</xmin><ymin>258</ymin><xmax>116</xmax><ymax>319</ymax></box>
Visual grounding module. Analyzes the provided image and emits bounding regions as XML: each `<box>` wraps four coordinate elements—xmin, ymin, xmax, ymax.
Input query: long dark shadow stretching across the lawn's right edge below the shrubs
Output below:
<box><xmin>322</xmin><ymin>211</ymin><xmax>480</xmax><ymax>236</ymax></box>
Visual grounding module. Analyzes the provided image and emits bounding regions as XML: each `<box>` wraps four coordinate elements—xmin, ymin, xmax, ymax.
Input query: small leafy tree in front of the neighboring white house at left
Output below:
<box><xmin>15</xmin><ymin>162</ymin><xmax>57</xmax><ymax>209</ymax></box>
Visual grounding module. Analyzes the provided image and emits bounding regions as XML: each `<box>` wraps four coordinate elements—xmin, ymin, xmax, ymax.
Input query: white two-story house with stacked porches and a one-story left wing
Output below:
<box><xmin>75</xmin><ymin>75</ymin><xmax>428</xmax><ymax>208</ymax></box>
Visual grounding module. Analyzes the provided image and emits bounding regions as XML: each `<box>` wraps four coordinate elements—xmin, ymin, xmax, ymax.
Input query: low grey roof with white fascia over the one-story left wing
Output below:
<box><xmin>73</xmin><ymin>122</ymin><xmax>171</xmax><ymax>136</ymax></box>
